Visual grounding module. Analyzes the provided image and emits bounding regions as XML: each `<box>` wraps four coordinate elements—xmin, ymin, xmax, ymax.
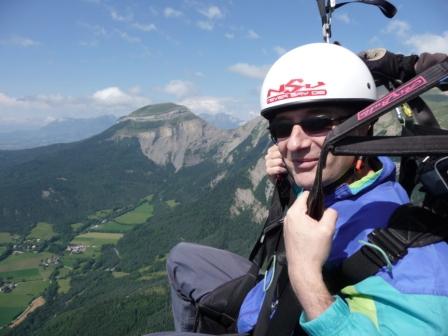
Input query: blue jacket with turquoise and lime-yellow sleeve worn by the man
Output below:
<box><xmin>237</xmin><ymin>157</ymin><xmax>448</xmax><ymax>335</ymax></box>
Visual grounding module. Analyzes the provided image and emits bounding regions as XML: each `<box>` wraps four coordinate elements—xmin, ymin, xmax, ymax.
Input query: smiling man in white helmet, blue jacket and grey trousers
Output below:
<box><xmin>151</xmin><ymin>43</ymin><xmax>448</xmax><ymax>335</ymax></box>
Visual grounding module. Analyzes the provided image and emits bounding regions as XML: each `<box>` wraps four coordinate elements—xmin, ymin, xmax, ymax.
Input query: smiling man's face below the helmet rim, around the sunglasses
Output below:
<box><xmin>272</xmin><ymin>107</ymin><xmax>355</xmax><ymax>189</ymax></box>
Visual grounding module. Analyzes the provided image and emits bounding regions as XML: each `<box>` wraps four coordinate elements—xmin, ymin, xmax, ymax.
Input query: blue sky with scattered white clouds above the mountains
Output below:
<box><xmin>0</xmin><ymin>0</ymin><xmax>448</xmax><ymax>131</ymax></box>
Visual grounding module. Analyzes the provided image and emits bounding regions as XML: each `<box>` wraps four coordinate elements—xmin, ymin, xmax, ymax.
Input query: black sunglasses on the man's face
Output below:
<box><xmin>268</xmin><ymin>115</ymin><xmax>348</xmax><ymax>142</ymax></box>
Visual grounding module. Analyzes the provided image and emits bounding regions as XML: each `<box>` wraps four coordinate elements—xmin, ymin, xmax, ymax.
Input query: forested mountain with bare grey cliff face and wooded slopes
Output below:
<box><xmin>0</xmin><ymin>104</ymin><xmax>270</xmax><ymax>335</ymax></box>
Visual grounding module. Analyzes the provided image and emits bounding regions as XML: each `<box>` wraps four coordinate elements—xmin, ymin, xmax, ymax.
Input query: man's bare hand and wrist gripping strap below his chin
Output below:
<box><xmin>283</xmin><ymin>191</ymin><xmax>338</xmax><ymax>320</ymax></box>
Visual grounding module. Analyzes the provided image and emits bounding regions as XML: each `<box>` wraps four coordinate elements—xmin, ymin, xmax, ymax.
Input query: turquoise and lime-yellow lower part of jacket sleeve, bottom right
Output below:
<box><xmin>300</xmin><ymin>276</ymin><xmax>448</xmax><ymax>336</ymax></box>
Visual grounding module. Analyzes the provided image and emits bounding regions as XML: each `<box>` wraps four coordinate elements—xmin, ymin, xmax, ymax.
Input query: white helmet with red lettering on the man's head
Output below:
<box><xmin>260</xmin><ymin>43</ymin><xmax>376</xmax><ymax>119</ymax></box>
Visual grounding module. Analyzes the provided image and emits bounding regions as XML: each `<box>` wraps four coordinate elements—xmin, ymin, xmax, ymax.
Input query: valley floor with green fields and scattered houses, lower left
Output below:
<box><xmin>0</xmin><ymin>196</ymin><xmax>163</xmax><ymax>335</ymax></box>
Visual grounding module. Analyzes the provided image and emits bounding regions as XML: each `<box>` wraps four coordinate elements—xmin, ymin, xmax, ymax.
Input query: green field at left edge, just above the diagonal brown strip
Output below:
<box><xmin>0</xmin><ymin>280</ymin><xmax>49</xmax><ymax>326</ymax></box>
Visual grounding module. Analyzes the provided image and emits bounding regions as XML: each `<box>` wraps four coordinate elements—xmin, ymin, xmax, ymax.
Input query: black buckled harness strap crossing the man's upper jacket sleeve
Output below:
<box><xmin>327</xmin><ymin>204</ymin><xmax>448</xmax><ymax>289</ymax></box>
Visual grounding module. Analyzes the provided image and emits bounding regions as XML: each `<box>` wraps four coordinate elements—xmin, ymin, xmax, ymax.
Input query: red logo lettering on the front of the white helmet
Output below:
<box><xmin>267</xmin><ymin>78</ymin><xmax>327</xmax><ymax>104</ymax></box>
